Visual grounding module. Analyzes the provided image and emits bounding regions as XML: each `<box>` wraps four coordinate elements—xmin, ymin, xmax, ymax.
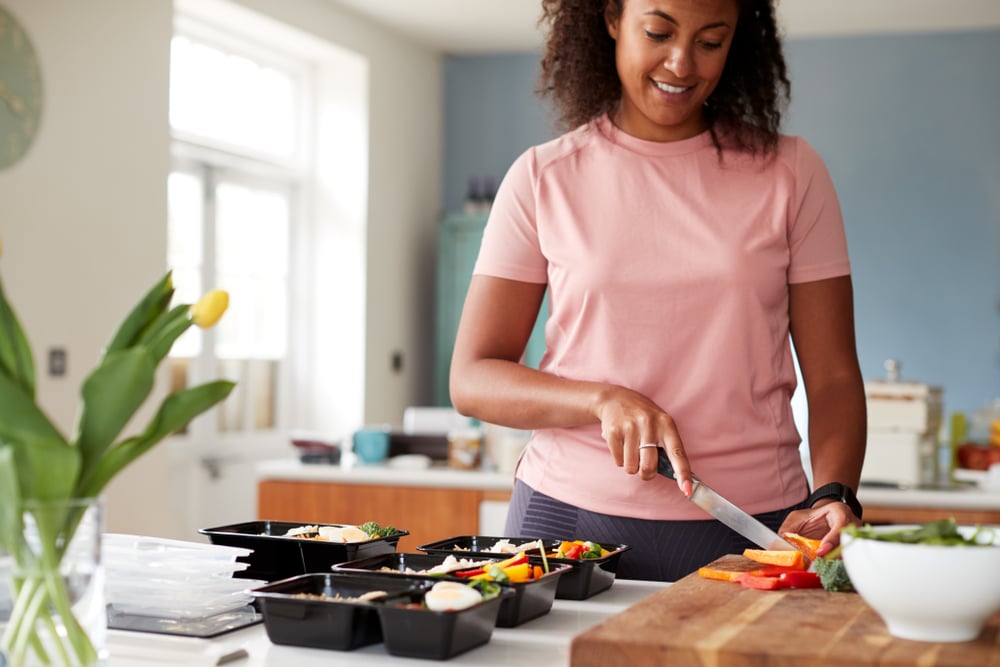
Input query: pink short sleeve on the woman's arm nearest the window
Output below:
<box><xmin>473</xmin><ymin>148</ymin><xmax>548</xmax><ymax>284</ymax></box>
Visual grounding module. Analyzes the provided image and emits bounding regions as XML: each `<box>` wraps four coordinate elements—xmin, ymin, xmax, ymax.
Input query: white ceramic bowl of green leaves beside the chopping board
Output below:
<box><xmin>841</xmin><ymin>525</ymin><xmax>1000</xmax><ymax>642</ymax></box>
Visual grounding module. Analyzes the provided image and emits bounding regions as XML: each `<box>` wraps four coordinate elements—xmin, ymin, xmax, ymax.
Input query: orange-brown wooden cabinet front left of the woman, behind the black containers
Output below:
<box><xmin>257</xmin><ymin>480</ymin><xmax>510</xmax><ymax>552</ymax></box>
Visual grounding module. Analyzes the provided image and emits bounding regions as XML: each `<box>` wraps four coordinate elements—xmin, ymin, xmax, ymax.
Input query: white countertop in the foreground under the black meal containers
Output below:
<box><xmin>108</xmin><ymin>579</ymin><xmax>670</xmax><ymax>667</ymax></box>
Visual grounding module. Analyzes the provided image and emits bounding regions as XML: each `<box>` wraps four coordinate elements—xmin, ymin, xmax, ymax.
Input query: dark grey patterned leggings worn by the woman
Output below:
<box><xmin>504</xmin><ymin>480</ymin><xmax>805</xmax><ymax>581</ymax></box>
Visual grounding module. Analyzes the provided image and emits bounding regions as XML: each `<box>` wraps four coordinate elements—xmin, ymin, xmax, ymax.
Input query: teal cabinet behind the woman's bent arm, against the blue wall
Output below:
<box><xmin>434</xmin><ymin>213</ymin><xmax>549</xmax><ymax>406</ymax></box>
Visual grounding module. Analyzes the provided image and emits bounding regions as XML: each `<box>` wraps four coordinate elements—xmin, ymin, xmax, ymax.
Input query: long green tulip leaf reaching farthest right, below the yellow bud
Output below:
<box><xmin>77</xmin><ymin>380</ymin><xmax>236</xmax><ymax>496</ymax></box>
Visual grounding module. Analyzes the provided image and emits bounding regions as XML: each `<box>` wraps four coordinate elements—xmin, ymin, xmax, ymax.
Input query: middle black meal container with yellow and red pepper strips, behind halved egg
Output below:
<box><xmin>333</xmin><ymin>553</ymin><xmax>572</xmax><ymax>628</ymax></box>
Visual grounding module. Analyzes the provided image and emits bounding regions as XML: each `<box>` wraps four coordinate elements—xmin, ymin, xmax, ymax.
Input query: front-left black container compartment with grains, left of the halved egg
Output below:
<box><xmin>252</xmin><ymin>573</ymin><xmax>431</xmax><ymax>651</ymax></box>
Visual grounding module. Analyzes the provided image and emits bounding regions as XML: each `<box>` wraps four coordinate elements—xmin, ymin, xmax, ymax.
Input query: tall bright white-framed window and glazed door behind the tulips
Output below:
<box><xmin>167</xmin><ymin>0</ymin><xmax>370</xmax><ymax>452</ymax></box>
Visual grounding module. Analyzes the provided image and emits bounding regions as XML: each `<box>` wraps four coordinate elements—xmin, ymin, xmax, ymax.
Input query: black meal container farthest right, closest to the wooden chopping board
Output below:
<box><xmin>417</xmin><ymin>535</ymin><xmax>632</xmax><ymax>600</ymax></box>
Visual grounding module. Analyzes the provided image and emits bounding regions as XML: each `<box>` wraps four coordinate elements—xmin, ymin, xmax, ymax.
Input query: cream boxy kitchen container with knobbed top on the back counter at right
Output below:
<box><xmin>861</xmin><ymin>359</ymin><xmax>942</xmax><ymax>486</ymax></box>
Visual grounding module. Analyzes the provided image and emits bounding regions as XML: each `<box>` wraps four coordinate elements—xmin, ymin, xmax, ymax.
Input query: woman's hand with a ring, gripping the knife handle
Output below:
<box><xmin>594</xmin><ymin>385</ymin><xmax>692</xmax><ymax>496</ymax></box>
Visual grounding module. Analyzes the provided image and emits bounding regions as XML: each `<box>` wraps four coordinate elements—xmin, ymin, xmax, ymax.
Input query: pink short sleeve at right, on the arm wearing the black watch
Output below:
<box><xmin>788</xmin><ymin>138</ymin><xmax>851</xmax><ymax>283</ymax></box>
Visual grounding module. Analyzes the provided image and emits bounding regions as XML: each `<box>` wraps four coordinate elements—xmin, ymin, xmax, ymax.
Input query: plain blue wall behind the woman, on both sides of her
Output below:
<box><xmin>442</xmin><ymin>31</ymin><xmax>1000</xmax><ymax>420</ymax></box>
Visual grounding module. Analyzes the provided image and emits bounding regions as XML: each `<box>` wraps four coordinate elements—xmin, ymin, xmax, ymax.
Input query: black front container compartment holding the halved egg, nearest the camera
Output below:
<box><xmin>376</xmin><ymin>573</ymin><xmax>514</xmax><ymax>660</ymax></box>
